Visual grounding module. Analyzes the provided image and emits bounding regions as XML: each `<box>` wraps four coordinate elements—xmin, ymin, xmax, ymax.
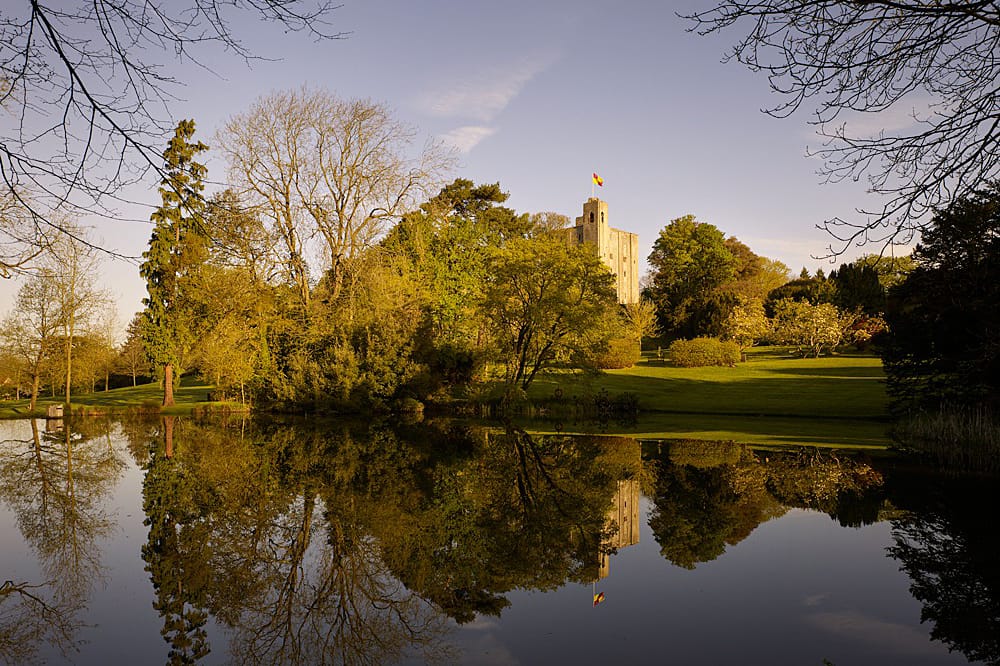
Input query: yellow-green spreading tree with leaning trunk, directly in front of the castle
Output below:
<box><xmin>483</xmin><ymin>237</ymin><xmax>616</xmax><ymax>391</ymax></box>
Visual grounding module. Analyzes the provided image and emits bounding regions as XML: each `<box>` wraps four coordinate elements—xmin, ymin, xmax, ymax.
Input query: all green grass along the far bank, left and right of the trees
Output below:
<box><xmin>0</xmin><ymin>348</ymin><xmax>890</xmax><ymax>450</ymax></box>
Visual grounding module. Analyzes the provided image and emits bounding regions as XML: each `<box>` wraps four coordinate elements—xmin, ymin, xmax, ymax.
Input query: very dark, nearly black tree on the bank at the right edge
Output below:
<box><xmin>882</xmin><ymin>185</ymin><xmax>1000</xmax><ymax>410</ymax></box>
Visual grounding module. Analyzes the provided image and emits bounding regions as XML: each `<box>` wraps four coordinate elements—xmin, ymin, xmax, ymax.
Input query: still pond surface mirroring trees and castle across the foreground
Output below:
<box><xmin>0</xmin><ymin>418</ymin><xmax>1000</xmax><ymax>666</ymax></box>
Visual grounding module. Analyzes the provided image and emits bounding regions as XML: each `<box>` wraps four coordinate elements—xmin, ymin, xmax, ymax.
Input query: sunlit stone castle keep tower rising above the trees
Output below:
<box><xmin>564</xmin><ymin>197</ymin><xmax>639</xmax><ymax>303</ymax></box>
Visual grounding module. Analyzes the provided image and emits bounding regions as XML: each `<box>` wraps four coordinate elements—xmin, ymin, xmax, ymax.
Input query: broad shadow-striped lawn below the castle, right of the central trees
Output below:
<box><xmin>529</xmin><ymin>348</ymin><xmax>889</xmax><ymax>448</ymax></box>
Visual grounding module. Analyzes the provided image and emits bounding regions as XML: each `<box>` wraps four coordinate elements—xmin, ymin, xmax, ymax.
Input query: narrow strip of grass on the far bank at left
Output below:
<box><xmin>0</xmin><ymin>378</ymin><xmax>241</xmax><ymax>419</ymax></box>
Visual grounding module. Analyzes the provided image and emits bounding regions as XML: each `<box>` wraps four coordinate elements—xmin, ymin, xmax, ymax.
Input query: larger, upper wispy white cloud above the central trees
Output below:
<box><xmin>418</xmin><ymin>57</ymin><xmax>553</xmax><ymax>123</ymax></box>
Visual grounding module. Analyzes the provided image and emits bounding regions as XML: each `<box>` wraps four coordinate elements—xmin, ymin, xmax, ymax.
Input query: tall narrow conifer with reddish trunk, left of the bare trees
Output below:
<box><xmin>139</xmin><ymin>120</ymin><xmax>208</xmax><ymax>407</ymax></box>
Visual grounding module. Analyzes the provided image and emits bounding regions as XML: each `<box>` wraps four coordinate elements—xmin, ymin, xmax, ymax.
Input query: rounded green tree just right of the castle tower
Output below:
<box><xmin>649</xmin><ymin>215</ymin><xmax>736</xmax><ymax>337</ymax></box>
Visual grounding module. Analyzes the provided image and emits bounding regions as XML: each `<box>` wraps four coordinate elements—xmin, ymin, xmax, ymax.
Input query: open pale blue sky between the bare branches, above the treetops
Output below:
<box><xmin>0</xmin><ymin>0</ymin><xmax>908</xmax><ymax>321</ymax></box>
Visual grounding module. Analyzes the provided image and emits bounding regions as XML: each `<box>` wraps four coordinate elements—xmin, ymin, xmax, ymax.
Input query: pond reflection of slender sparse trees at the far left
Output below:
<box><xmin>0</xmin><ymin>420</ymin><xmax>125</xmax><ymax>663</ymax></box>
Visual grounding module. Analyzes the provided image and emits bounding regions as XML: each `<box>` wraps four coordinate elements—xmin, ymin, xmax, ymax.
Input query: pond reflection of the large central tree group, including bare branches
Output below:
<box><xmin>143</xmin><ymin>421</ymin><xmax>639</xmax><ymax>663</ymax></box>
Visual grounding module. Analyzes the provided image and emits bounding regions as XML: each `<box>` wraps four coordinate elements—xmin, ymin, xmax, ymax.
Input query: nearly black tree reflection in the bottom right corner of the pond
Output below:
<box><xmin>889</xmin><ymin>476</ymin><xmax>1000</xmax><ymax>664</ymax></box>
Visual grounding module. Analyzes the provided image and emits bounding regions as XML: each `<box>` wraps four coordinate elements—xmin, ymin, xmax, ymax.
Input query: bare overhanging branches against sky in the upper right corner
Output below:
<box><xmin>682</xmin><ymin>0</ymin><xmax>1000</xmax><ymax>257</ymax></box>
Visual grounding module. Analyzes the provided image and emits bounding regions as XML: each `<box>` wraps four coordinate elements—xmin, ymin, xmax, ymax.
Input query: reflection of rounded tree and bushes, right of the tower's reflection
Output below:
<box><xmin>645</xmin><ymin>440</ymin><xmax>882</xmax><ymax>569</ymax></box>
